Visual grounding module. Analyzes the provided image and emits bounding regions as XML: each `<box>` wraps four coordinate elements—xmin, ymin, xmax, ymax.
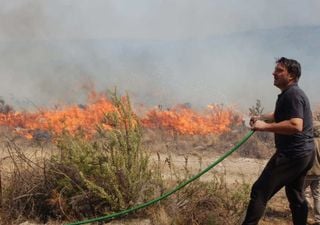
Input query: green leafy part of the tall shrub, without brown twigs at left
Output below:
<box><xmin>49</xmin><ymin>91</ymin><xmax>161</xmax><ymax>216</ymax></box>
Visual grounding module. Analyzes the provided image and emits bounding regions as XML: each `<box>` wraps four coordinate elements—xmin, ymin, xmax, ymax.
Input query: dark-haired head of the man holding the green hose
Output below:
<box><xmin>272</xmin><ymin>57</ymin><xmax>301</xmax><ymax>90</ymax></box>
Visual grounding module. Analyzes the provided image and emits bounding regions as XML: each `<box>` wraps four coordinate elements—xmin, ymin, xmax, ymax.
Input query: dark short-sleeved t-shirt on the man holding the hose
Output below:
<box><xmin>274</xmin><ymin>84</ymin><xmax>314</xmax><ymax>157</ymax></box>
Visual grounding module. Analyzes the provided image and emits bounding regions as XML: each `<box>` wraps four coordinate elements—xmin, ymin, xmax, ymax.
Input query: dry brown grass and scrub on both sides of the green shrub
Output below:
<box><xmin>0</xmin><ymin>103</ymin><xmax>308</xmax><ymax>225</ymax></box>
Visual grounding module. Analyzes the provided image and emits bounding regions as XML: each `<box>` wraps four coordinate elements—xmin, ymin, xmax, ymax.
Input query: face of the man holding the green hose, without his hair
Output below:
<box><xmin>272</xmin><ymin>63</ymin><xmax>294</xmax><ymax>90</ymax></box>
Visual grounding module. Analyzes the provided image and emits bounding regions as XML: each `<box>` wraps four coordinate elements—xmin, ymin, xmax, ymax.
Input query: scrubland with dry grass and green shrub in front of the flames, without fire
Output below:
<box><xmin>0</xmin><ymin>95</ymin><xmax>318</xmax><ymax>225</ymax></box>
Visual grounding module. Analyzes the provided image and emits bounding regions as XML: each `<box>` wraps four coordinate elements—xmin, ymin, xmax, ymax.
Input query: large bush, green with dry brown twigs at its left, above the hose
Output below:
<box><xmin>3</xmin><ymin>94</ymin><xmax>160</xmax><ymax>221</ymax></box>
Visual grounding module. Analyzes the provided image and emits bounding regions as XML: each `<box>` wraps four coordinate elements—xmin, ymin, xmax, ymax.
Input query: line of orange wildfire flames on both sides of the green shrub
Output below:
<box><xmin>0</xmin><ymin>92</ymin><xmax>240</xmax><ymax>139</ymax></box>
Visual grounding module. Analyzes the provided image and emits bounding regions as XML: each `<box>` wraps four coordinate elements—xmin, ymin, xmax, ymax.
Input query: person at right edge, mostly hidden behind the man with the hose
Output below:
<box><xmin>304</xmin><ymin>121</ymin><xmax>320</xmax><ymax>225</ymax></box>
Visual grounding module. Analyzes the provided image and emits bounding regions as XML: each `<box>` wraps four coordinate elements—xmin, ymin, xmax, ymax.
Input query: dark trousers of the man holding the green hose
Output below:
<box><xmin>242</xmin><ymin>151</ymin><xmax>314</xmax><ymax>225</ymax></box>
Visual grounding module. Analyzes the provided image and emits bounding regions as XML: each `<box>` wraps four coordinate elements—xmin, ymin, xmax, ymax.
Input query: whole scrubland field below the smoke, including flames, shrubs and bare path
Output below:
<box><xmin>0</xmin><ymin>96</ymin><xmax>318</xmax><ymax>225</ymax></box>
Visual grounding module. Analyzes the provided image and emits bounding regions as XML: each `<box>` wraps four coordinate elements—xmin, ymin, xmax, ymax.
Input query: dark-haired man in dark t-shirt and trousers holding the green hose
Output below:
<box><xmin>243</xmin><ymin>57</ymin><xmax>314</xmax><ymax>225</ymax></box>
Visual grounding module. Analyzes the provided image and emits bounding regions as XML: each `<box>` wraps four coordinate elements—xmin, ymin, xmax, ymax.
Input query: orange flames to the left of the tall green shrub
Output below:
<box><xmin>0</xmin><ymin>94</ymin><xmax>114</xmax><ymax>138</ymax></box>
